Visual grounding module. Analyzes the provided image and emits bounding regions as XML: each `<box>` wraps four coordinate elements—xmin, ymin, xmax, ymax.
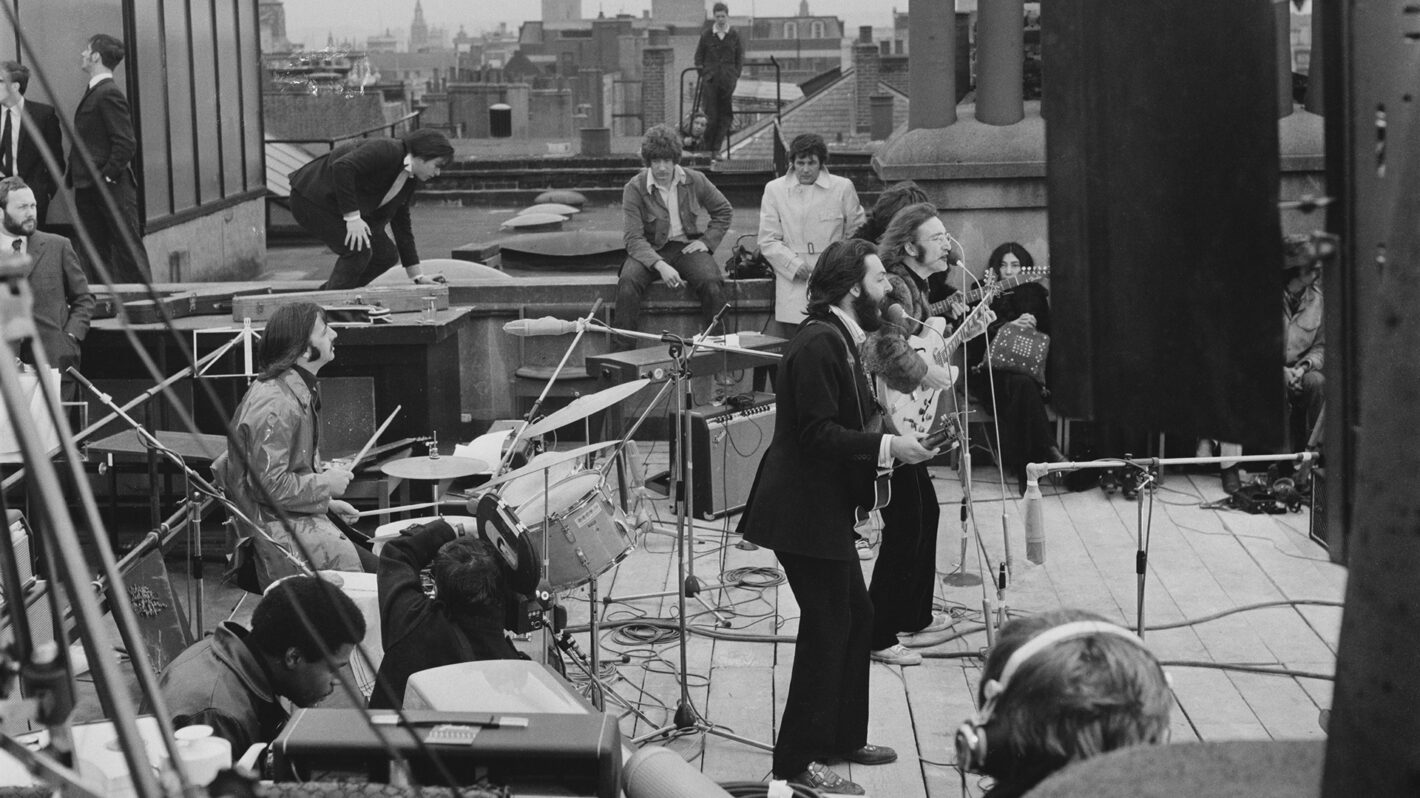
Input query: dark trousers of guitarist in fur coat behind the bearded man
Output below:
<box><xmin>868</xmin><ymin>464</ymin><xmax>941</xmax><ymax>652</ymax></box>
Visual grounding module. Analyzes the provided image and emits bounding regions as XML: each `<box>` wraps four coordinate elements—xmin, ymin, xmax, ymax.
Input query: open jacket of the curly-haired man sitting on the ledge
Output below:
<box><xmin>622</xmin><ymin>168</ymin><xmax>734</xmax><ymax>268</ymax></box>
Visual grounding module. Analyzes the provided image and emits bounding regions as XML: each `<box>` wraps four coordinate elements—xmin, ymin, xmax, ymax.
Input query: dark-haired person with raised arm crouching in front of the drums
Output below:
<box><xmin>369</xmin><ymin>520</ymin><xmax>538</xmax><ymax>709</ymax></box>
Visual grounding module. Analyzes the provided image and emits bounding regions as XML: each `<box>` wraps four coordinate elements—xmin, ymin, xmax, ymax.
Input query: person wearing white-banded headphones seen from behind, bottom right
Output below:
<box><xmin>956</xmin><ymin>609</ymin><xmax>1173</xmax><ymax>798</ymax></box>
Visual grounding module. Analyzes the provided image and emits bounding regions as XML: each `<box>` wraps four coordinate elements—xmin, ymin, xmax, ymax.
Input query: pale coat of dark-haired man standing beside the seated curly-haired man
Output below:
<box><xmin>760</xmin><ymin>168</ymin><xmax>865</xmax><ymax>324</ymax></box>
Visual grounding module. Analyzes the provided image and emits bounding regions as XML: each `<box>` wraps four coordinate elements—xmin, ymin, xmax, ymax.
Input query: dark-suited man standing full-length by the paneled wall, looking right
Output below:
<box><xmin>65</xmin><ymin>33</ymin><xmax>152</xmax><ymax>283</ymax></box>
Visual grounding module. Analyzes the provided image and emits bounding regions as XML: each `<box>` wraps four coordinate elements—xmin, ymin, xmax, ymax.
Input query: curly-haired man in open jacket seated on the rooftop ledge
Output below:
<box><xmin>616</xmin><ymin>125</ymin><xmax>734</xmax><ymax>349</ymax></box>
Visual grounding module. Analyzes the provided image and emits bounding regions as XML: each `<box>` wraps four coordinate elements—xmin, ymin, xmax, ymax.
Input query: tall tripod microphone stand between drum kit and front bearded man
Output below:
<box><xmin>592</xmin><ymin>305</ymin><xmax>777</xmax><ymax>751</ymax></box>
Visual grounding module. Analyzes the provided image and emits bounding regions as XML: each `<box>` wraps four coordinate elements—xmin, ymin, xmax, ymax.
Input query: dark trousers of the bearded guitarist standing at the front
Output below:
<box><xmin>774</xmin><ymin>552</ymin><xmax>873</xmax><ymax>778</ymax></box>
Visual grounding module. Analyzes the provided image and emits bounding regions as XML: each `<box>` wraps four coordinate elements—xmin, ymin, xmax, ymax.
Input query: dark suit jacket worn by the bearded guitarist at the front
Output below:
<box><xmin>743</xmin><ymin>314</ymin><xmax>882</xmax><ymax>559</ymax></box>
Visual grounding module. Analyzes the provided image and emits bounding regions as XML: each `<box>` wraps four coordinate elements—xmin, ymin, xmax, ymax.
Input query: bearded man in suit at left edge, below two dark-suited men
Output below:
<box><xmin>0</xmin><ymin>177</ymin><xmax>94</xmax><ymax>386</ymax></box>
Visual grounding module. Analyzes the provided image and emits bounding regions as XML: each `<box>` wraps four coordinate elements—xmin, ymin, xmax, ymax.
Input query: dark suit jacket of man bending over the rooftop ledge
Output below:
<box><xmin>291</xmin><ymin>139</ymin><xmax>419</xmax><ymax>267</ymax></box>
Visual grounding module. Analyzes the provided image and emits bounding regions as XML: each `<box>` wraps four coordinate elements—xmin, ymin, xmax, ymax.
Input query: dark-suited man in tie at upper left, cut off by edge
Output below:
<box><xmin>0</xmin><ymin>61</ymin><xmax>64</xmax><ymax>227</ymax></box>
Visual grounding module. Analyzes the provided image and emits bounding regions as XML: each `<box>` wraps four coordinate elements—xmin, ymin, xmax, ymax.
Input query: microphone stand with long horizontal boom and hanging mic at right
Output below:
<box><xmin>1025</xmin><ymin>452</ymin><xmax>1316</xmax><ymax>639</ymax></box>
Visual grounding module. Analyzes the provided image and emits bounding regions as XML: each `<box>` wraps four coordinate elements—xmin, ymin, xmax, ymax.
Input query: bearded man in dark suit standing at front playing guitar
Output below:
<box><xmin>743</xmin><ymin>240</ymin><xmax>934</xmax><ymax>795</ymax></box>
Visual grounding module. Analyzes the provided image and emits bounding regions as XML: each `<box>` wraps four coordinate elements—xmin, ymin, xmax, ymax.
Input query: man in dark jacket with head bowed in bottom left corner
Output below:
<box><xmin>158</xmin><ymin>576</ymin><xmax>365</xmax><ymax>758</ymax></box>
